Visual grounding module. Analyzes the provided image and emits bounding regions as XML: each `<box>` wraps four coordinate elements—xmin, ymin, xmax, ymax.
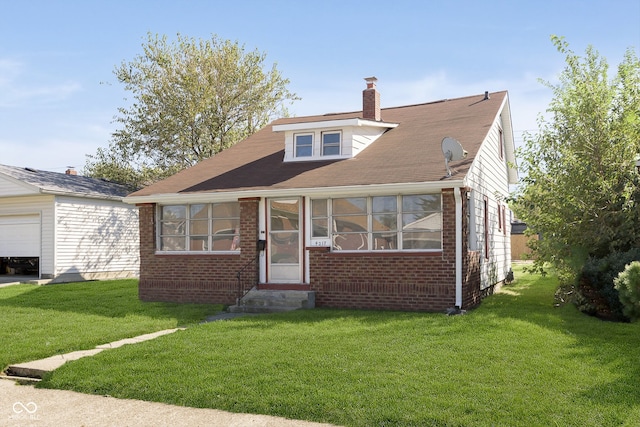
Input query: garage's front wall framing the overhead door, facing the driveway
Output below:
<box><xmin>0</xmin><ymin>195</ymin><xmax>55</xmax><ymax>278</ymax></box>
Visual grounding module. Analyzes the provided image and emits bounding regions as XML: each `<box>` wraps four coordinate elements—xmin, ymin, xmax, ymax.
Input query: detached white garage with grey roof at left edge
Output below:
<box><xmin>0</xmin><ymin>165</ymin><xmax>140</xmax><ymax>282</ymax></box>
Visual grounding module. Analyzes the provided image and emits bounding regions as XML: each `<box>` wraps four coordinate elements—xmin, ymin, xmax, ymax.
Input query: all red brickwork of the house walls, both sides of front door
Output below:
<box><xmin>140</xmin><ymin>189</ymin><xmax>483</xmax><ymax>311</ymax></box>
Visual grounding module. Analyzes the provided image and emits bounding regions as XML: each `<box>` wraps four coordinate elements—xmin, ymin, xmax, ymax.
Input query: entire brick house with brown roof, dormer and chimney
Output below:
<box><xmin>125</xmin><ymin>78</ymin><xmax>517</xmax><ymax>311</ymax></box>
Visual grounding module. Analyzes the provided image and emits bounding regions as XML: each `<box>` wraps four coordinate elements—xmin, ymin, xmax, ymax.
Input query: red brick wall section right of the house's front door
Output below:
<box><xmin>309</xmin><ymin>189</ymin><xmax>479</xmax><ymax>311</ymax></box>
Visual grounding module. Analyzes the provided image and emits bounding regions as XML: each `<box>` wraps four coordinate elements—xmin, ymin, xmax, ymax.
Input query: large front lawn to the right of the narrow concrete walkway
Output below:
<box><xmin>40</xmin><ymin>270</ymin><xmax>640</xmax><ymax>426</ymax></box>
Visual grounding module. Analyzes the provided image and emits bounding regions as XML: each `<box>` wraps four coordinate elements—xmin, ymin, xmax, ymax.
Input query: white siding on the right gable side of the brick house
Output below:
<box><xmin>467</xmin><ymin>104</ymin><xmax>511</xmax><ymax>288</ymax></box>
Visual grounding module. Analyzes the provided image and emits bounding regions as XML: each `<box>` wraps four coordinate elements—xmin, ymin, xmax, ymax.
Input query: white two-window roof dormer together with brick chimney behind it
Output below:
<box><xmin>273</xmin><ymin>77</ymin><xmax>398</xmax><ymax>162</ymax></box>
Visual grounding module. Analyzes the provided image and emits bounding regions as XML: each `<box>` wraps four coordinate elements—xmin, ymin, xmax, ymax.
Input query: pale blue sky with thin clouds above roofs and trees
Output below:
<box><xmin>0</xmin><ymin>0</ymin><xmax>640</xmax><ymax>172</ymax></box>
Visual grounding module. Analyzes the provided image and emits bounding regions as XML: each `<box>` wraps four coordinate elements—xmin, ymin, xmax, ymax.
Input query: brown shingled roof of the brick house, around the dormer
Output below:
<box><xmin>131</xmin><ymin>91</ymin><xmax>507</xmax><ymax>198</ymax></box>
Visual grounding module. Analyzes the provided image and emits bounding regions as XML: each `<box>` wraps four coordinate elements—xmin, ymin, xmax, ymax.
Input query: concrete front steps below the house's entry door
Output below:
<box><xmin>229</xmin><ymin>288</ymin><xmax>316</xmax><ymax>313</ymax></box>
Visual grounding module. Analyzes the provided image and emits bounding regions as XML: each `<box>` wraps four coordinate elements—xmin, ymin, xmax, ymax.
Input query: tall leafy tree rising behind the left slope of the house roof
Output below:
<box><xmin>84</xmin><ymin>33</ymin><xmax>298</xmax><ymax>188</ymax></box>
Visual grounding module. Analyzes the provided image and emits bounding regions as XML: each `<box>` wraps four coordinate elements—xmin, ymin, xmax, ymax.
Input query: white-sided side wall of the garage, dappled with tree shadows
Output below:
<box><xmin>55</xmin><ymin>196</ymin><xmax>139</xmax><ymax>281</ymax></box>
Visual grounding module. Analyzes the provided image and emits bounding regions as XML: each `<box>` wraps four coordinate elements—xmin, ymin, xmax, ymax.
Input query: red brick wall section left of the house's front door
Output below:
<box><xmin>138</xmin><ymin>199</ymin><xmax>259</xmax><ymax>304</ymax></box>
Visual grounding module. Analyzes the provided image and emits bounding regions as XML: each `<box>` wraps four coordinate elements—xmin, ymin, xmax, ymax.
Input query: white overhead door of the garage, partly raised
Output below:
<box><xmin>0</xmin><ymin>215</ymin><xmax>40</xmax><ymax>257</ymax></box>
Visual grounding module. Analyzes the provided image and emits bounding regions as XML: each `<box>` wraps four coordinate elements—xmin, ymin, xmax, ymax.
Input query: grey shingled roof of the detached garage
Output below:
<box><xmin>0</xmin><ymin>165</ymin><xmax>129</xmax><ymax>200</ymax></box>
